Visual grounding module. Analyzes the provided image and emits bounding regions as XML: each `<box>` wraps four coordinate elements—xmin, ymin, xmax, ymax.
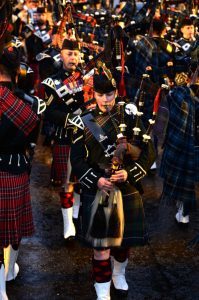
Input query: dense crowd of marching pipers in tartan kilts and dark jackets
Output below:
<box><xmin>0</xmin><ymin>0</ymin><xmax>199</xmax><ymax>300</ymax></box>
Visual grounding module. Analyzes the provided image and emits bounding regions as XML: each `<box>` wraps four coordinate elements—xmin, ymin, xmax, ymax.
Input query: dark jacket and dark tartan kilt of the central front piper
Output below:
<box><xmin>70</xmin><ymin>102</ymin><xmax>154</xmax><ymax>247</ymax></box>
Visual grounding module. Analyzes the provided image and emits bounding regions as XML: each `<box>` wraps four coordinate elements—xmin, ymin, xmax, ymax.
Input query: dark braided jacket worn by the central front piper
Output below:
<box><xmin>71</xmin><ymin>104</ymin><xmax>155</xmax><ymax>194</ymax></box>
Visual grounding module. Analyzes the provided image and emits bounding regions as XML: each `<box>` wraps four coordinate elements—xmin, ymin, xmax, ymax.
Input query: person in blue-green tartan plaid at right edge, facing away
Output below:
<box><xmin>160</xmin><ymin>62</ymin><xmax>199</xmax><ymax>228</ymax></box>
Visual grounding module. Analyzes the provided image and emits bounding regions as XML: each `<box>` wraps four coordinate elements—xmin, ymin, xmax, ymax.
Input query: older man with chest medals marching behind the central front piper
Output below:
<box><xmin>42</xmin><ymin>39</ymin><xmax>84</xmax><ymax>239</ymax></box>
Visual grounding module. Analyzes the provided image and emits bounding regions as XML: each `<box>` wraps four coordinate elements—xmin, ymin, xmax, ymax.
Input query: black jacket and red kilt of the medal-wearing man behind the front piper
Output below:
<box><xmin>42</xmin><ymin>69</ymin><xmax>84</xmax><ymax>184</ymax></box>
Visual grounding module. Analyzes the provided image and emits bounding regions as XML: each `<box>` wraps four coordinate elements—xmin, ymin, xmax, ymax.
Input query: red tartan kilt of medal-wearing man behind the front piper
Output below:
<box><xmin>51</xmin><ymin>143</ymin><xmax>70</xmax><ymax>185</ymax></box>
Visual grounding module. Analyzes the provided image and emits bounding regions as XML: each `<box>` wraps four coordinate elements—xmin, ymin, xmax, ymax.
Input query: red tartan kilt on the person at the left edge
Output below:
<box><xmin>0</xmin><ymin>171</ymin><xmax>34</xmax><ymax>247</ymax></box>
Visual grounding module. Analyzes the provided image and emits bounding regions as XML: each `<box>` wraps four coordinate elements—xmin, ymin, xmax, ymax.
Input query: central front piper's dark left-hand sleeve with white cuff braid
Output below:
<box><xmin>70</xmin><ymin>129</ymin><xmax>102</xmax><ymax>189</ymax></box>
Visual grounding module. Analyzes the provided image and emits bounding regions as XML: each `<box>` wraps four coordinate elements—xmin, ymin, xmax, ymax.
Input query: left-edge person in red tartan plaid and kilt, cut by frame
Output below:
<box><xmin>0</xmin><ymin>46</ymin><xmax>46</xmax><ymax>300</ymax></box>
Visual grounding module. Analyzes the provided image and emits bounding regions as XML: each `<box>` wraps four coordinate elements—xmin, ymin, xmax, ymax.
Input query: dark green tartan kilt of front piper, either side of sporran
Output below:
<box><xmin>77</xmin><ymin>189</ymin><xmax>148</xmax><ymax>248</ymax></box>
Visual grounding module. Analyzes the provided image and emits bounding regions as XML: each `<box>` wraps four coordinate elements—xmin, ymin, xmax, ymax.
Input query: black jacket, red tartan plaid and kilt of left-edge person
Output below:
<box><xmin>0</xmin><ymin>83</ymin><xmax>45</xmax><ymax>247</ymax></box>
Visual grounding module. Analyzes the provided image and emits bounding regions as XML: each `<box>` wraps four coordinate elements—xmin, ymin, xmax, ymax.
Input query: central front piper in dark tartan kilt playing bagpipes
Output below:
<box><xmin>70</xmin><ymin>63</ymin><xmax>155</xmax><ymax>300</ymax></box>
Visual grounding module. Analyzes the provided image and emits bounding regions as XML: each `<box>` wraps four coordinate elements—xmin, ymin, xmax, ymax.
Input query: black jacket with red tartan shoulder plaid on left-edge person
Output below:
<box><xmin>0</xmin><ymin>82</ymin><xmax>40</xmax><ymax>174</ymax></box>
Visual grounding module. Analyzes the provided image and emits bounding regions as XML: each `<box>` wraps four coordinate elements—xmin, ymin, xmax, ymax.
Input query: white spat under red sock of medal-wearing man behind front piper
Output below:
<box><xmin>61</xmin><ymin>207</ymin><xmax>76</xmax><ymax>239</ymax></box>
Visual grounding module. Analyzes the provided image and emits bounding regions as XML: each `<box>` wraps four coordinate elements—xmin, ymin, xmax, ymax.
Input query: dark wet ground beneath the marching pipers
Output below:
<box><xmin>7</xmin><ymin>141</ymin><xmax>199</xmax><ymax>300</ymax></box>
